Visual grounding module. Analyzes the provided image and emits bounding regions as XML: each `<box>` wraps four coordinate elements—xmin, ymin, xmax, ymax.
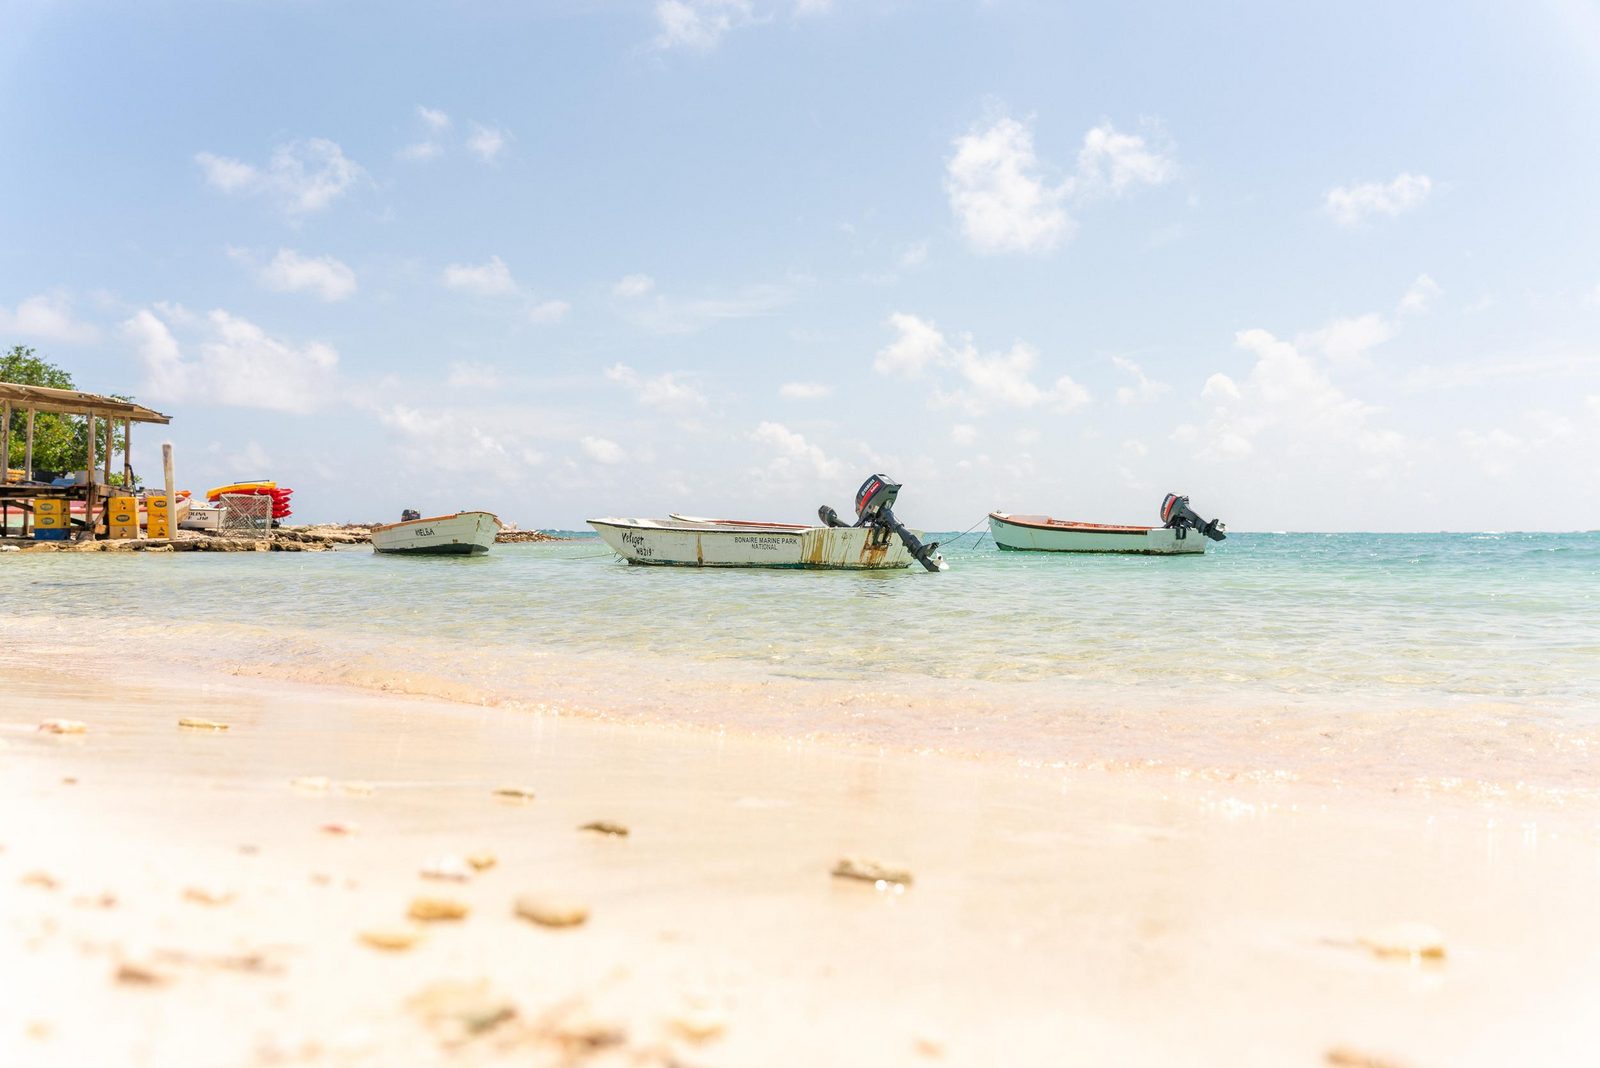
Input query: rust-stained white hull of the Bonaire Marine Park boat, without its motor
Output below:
<box><xmin>589</xmin><ymin>518</ymin><xmax>922</xmax><ymax>571</ymax></box>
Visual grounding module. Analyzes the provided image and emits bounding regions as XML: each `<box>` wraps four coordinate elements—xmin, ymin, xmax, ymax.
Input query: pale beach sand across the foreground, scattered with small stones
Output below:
<box><xmin>0</xmin><ymin>667</ymin><xmax>1600</xmax><ymax>1068</ymax></box>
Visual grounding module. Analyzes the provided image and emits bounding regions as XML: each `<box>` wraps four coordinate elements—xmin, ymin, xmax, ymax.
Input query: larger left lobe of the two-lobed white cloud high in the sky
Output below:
<box><xmin>944</xmin><ymin>117</ymin><xmax>1074</xmax><ymax>253</ymax></box>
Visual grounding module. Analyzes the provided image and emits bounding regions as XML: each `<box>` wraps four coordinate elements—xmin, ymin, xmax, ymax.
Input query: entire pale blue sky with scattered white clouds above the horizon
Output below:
<box><xmin>0</xmin><ymin>0</ymin><xmax>1600</xmax><ymax>529</ymax></box>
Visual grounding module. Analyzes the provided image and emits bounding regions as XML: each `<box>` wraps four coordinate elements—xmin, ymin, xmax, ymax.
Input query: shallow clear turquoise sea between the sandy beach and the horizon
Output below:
<box><xmin>0</xmin><ymin>534</ymin><xmax>1600</xmax><ymax>789</ymax></box>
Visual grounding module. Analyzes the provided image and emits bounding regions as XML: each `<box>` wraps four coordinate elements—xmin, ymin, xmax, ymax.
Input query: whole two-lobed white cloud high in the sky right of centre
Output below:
<box><xmin>944</xmin><ymin>115</ymin><xmax>1178</xmax><ymax>254</ymax></box>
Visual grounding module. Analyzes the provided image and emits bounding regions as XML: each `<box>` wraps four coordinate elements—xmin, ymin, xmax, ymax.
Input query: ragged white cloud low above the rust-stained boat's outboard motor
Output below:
<box><xmin>874</xmin><ymin>313</ymin><xmax>1090</xmax><ymax>416</ymax></box>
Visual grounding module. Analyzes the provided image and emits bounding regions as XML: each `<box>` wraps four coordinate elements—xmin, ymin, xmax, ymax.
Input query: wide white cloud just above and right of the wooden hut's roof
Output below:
<box><xmin>123</xmin><ymin>309</ymin><xmax>339</xmax><ymax>412</ymax></box>
